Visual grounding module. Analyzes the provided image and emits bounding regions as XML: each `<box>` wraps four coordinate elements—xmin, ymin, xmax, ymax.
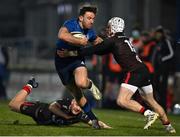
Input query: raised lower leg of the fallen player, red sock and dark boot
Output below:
<box><xmin>9</xmin><ymin>78</ymin><xmax>38</xmax><ymax>112</ymax></box>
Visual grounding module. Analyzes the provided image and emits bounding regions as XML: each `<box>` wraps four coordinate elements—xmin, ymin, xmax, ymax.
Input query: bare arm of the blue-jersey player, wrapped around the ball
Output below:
<box><xmin>58</xmin><ymin>27</ymin><xmax>88</xmax><ymax>46</ymax></box>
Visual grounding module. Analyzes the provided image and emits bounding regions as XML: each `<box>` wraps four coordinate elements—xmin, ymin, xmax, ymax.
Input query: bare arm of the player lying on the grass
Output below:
<box><xmin>49</xmin><ymin>102</ymin><xmax>73</xmax><ymax>119</ymax></box>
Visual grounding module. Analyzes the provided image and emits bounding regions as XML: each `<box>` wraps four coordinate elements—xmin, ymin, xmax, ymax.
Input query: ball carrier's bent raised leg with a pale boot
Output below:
<box><xmin>74</xmin><ymin>66</ymin><xmax>102</xmax><ymax>100</ymax></box>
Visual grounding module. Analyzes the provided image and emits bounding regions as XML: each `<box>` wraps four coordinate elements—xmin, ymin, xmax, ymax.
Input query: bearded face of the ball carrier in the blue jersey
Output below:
<box><xmin>79</xmin><ymin>12</ymin><xmax>96</xmax><ymax>29</ymax></box>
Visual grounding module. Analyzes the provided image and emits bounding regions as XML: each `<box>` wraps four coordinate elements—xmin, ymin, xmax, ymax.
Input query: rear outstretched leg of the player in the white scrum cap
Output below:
<box><xmin>140</xmin><ymin>85</ymin><xmax>176</xmax><ymax>133</ymax></box>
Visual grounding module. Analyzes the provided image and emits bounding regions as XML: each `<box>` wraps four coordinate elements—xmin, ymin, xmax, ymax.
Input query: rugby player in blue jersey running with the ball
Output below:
<box><xmin>55</xmin><ymin>7</ymin><xmax>102</xmax><ymax>129</ymax></box>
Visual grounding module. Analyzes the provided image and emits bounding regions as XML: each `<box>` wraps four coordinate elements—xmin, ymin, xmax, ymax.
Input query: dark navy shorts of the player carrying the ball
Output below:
<box><xmin>55</xmin><ymin>54</ymin><xmax>86</xmax><ymax>85</ymax></box>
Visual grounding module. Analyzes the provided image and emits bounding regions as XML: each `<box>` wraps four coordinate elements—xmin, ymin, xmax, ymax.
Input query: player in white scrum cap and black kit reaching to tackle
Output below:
<box><xmin>58</xmin><ymin>17</ymin><xmax>176</xmax><ymax>133</ymax></box>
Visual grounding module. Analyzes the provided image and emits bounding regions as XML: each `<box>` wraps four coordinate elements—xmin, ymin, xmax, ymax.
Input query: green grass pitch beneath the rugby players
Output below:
<box><xmin>0</xmin><ymin>102</ymin><xmax>180</xmax><ymax>136</ymax></box>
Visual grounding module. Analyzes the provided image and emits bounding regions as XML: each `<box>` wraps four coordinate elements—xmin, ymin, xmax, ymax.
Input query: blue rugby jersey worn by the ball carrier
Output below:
<box><xmin>56</xmin><ymin>19</ymin><xmax>97</xmax><ymax>50</ymax></box>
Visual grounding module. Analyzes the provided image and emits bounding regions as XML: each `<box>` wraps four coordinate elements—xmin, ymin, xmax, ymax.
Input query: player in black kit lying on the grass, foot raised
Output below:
<box><xmin>9</xmin><ymin>78</ymin><xmax>111</xmax><ymax>128</ymax></box>
